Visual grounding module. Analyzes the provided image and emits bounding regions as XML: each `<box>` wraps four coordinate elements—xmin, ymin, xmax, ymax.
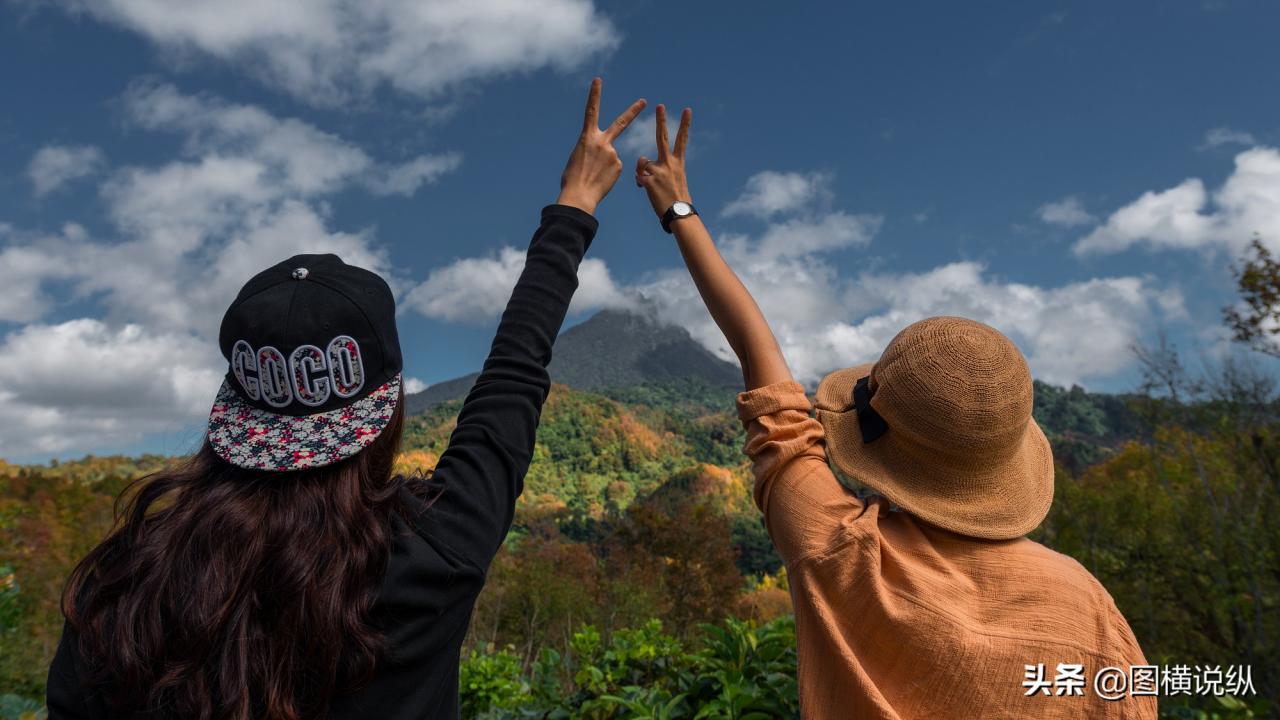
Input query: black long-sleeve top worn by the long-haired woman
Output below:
<box><xmin>47</xmin><ymin>205</ymin><xmax>596</xmax><ymax>720</ymax></box>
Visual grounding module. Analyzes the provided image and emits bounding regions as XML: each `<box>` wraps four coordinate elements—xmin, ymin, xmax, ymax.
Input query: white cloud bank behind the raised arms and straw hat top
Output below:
<box><xmin>396</xmin><ymin>169</ymin><xmax>1185</xmax><ymax>384</ymax></box>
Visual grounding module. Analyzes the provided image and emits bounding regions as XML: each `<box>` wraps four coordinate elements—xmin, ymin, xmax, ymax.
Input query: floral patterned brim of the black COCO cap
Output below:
<box><xmin>209</xmin><ymin>374</ymin><xmax>401</xmax><ymax>471</ymax></box>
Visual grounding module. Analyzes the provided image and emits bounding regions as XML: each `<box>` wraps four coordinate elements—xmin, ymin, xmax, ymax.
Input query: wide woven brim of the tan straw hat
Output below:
<box><xmin>815</xmin><ymin>363</ymin><xmax>1053</xmax><ymax>539</ymax></box>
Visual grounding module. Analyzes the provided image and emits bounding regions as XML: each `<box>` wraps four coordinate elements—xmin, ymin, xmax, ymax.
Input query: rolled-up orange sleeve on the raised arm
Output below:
<box><xmin>737</xmin><ymin>380</ymin><xmax>863</xmax><ymax>566</ymax></box>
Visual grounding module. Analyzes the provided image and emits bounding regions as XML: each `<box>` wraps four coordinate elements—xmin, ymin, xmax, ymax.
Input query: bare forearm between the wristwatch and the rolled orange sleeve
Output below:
<box><xmin>671</xmin><ymin>215</ymin><xmax>792</xmax><ymax>389</ymax></box>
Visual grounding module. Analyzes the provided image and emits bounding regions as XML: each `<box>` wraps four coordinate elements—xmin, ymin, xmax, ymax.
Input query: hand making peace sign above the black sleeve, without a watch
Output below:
<box><xmin>557</xmin><ymin>78</ymin><xmax>645</xmax><ymax>213</ymax></box>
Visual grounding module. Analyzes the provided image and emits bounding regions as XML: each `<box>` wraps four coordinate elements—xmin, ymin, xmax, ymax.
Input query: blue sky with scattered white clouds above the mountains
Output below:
<box><xmin>0</xmin><ymin>0</ymin><xmax>1280</xmax><ymax>461</ymax></box>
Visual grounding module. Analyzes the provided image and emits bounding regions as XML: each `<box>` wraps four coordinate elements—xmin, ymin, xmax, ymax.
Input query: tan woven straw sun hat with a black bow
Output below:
<box><xmin>815</xmin><ymin>318</ymin><xmax>1053</xmax><ymax>539</ymax></box>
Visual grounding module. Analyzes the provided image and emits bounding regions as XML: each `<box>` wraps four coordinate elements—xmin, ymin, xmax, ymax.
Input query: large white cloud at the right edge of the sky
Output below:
<box><xmin>1075</xmin><ymin>147</ymin><xmax>1280</xmax><ymax>255</ymax></box>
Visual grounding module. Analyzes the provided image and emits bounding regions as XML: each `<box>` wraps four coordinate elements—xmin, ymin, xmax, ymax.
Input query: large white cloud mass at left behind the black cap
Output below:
<box><xmin>0</xmin><ymin>82</ymin><xmax>457</xmax><ymax>456</ymax></box>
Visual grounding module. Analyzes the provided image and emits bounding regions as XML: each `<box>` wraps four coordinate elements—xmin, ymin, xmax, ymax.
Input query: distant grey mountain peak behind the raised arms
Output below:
<box><xmin>404</xmin><ymin>304</ymin><xmax>742</xmax><ymax>415</ymax></box>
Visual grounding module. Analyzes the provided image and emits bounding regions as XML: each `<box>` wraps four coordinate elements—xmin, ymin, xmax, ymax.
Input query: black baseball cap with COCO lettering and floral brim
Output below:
<box><xmin>207</xmin><ymin>254</ymin><xmax>403</xmax><ymax>471</ymax></box>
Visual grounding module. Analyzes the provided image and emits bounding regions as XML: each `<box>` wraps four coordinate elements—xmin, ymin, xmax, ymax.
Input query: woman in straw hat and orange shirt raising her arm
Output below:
<box><xmin>636</xmin><ymin>105</ymin><xmax>1156</xmax><ymax>719</ymax></box>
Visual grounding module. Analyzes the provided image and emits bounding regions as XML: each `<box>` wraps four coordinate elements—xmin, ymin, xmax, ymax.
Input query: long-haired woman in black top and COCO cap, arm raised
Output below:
<box><xmin>47</xmin><ymin>79</ymin><xmax>644</xmax><ymax>720</ymax></box>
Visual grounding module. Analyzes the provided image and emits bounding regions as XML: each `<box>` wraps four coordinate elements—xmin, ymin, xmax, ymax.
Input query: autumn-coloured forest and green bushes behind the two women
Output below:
<box><xmin>0</xmin><ymin>366</ymin><xmax>1280</xmax><ymax>719</ymax></box>
